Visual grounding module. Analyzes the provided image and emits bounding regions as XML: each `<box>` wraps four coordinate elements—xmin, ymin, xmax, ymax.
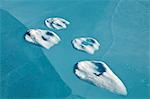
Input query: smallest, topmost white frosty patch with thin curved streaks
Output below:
<box><xmin>45</xmin><ymin>18</ymin><xmax>70</xmax><ymax>30</ymax></box>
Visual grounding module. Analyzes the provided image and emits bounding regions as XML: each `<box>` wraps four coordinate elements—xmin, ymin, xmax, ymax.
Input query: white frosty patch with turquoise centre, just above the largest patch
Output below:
<box><xmin>72</xmin><ymin>37</ymin><xmax>100</xmax><ymax>54</ymax></box>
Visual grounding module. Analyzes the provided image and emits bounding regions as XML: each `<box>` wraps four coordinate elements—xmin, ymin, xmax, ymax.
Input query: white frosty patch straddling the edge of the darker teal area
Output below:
<box><xmin>25</xmin><ymin>29</ymin><xmax>60</xmax><ymax>49</ymax></box>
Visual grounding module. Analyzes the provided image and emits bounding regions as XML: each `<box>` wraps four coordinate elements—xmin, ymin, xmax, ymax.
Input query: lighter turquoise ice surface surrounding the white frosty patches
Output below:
<box><xmin>1</xmin><ymin>0</ymin><xmax>150</xmax><ymax>99</ymax></box>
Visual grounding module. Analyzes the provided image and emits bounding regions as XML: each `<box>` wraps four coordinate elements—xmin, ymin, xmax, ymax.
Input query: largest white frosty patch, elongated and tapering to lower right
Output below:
<box><xmin>74</xmin><ymin>61</ymin><xmax>127</xmax><ymax>95</ymax></box>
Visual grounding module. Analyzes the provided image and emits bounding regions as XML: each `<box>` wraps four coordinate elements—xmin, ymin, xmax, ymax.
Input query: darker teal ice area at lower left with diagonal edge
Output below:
<box><xmin>0</xmin><ymin>10</ymin><xmax>71</xmax><ymax>99</ymax></box>
